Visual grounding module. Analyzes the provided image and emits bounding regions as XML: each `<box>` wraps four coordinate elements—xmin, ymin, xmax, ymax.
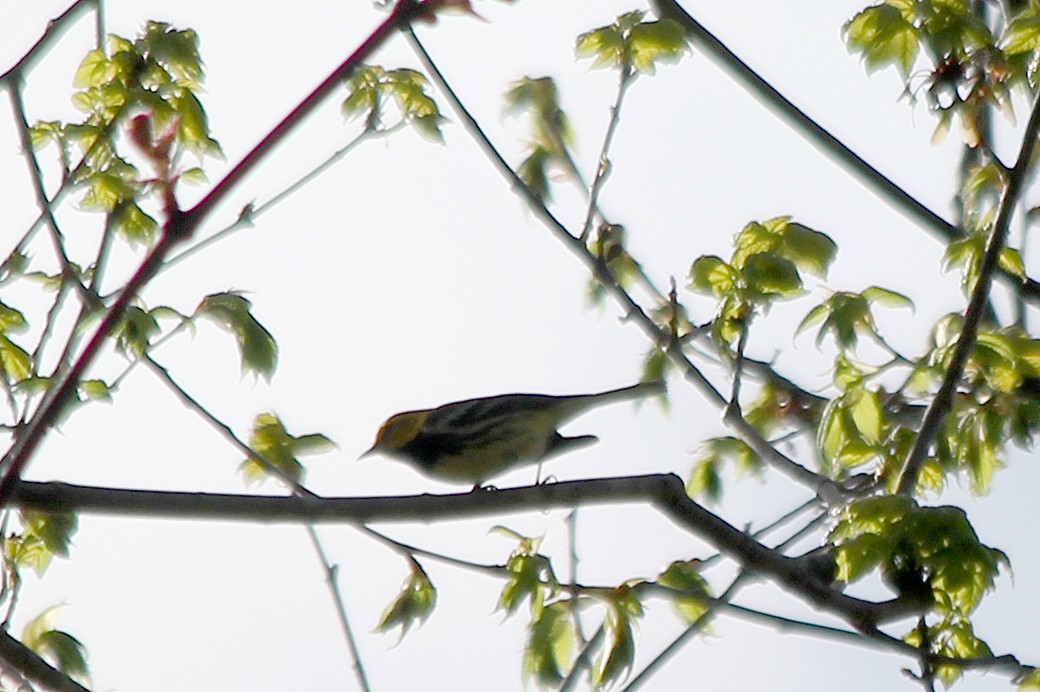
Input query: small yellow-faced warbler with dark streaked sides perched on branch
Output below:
<box><xmin>361</xmin><ymin>381</ymin><xmax>665</xmax><ymax>489</ymax></box>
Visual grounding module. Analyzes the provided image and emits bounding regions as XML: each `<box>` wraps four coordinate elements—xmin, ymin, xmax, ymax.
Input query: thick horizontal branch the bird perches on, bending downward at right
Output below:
<box><xmin>11</xmin><ymin>473</ymin><xmax>913</xmax><ymax>631</ymax></box>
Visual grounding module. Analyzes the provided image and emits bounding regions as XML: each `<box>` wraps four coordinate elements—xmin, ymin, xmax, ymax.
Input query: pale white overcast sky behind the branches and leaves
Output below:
<box><xmin>0</xmin><ymin>0</ymin><xmax>1040</xmax><ymax>691</ymax></box>
